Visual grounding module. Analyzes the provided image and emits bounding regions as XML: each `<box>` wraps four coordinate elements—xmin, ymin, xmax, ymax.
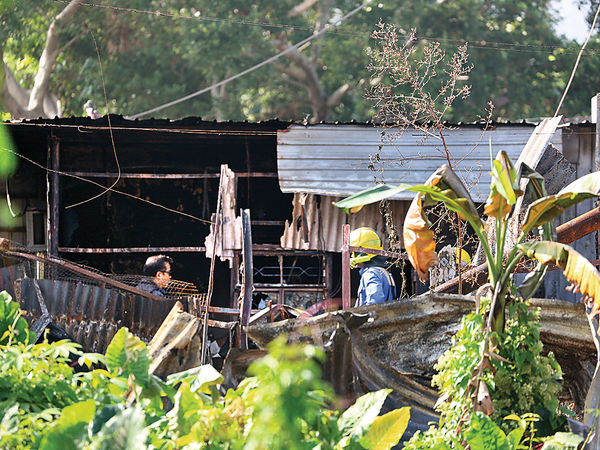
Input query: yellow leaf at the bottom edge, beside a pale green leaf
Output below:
<box><xmin>360</xmin><ymin>406</ymin><xmax>410</xmax><ymax>450</ymax></box>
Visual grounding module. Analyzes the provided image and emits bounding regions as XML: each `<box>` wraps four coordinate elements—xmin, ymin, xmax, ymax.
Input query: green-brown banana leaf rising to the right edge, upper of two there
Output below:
<box><xmin>523</xmin><ymin>172</ymin><xmax>600</xmax><ymax>232</ymax></box>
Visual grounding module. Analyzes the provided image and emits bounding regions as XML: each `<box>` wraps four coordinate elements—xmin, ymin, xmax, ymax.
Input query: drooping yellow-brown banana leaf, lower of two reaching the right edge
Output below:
<box><xmin>519</xmin><ymin>241</ymin><xmax>600</xmax><ymax>317</ymax></box>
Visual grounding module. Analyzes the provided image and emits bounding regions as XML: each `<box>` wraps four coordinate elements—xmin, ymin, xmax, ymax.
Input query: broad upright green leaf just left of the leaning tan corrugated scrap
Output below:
<box><xmin>106</xmin><ymin>327</ymin><xmax>152</xmax><ymax>387</ymax></box>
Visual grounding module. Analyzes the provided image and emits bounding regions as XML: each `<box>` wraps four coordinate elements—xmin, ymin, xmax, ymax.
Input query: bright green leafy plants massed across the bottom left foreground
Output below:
<box><xmin>0</xmin><ymin>294</ymin><xmax>409</xmax><ymax>450</ymax></box>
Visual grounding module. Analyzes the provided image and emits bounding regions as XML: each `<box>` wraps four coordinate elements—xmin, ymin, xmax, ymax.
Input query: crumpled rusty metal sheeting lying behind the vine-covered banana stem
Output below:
<box><xmin>248</xmin><ymin>294</ymin><xmax>596</xmax><ymax>432</ymax></box>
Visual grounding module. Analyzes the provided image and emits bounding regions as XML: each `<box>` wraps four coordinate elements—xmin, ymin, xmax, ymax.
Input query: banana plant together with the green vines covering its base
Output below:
<box><xmin>336</xmin><ymin>151</ymin><xmax>600</xmax><ymax>448</ymax></box>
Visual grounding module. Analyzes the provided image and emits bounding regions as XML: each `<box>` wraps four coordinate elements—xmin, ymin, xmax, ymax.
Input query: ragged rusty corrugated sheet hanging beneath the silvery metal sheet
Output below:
<box><xmin>280</xmin><ymin>194</ymin><xmax>409</xmax><ymax>252</ymax></box>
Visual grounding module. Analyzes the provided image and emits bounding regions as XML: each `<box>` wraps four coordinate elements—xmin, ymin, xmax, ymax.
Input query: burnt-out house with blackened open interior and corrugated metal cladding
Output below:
<box><xmin>0</xmin><ymin>116</ymin><xmax>596</xmax><ymax>307</ymax></box>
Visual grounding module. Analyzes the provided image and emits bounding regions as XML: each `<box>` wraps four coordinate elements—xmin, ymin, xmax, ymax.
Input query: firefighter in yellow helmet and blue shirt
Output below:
<box><xmin>350</xmin><ymin>227</ymin><xmax>396</xmax><ymax>306</ymax></box>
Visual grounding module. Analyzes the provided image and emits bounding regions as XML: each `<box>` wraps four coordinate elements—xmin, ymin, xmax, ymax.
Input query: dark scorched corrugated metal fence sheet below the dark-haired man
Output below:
<box><xmin>18</xmin><ymin>278</ymin><xmax>190</xmax><ymax>353</ymax></box>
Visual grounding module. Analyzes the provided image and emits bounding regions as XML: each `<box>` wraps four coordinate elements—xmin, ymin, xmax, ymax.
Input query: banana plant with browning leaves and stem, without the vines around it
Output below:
<box><xmin>335</xmin><ymin>151</ymin><xmax>600</xmax><ymax>432</ymax></box>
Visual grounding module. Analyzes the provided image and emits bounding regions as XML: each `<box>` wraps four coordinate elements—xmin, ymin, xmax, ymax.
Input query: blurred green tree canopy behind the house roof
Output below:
<box><xmin>0</xmin><ymin>0</ymin><xmax>600</xmax><ymax>121</ymax></box>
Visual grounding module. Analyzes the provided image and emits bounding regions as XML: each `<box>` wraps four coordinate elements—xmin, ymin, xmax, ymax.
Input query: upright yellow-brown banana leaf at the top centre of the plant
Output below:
<box><xmin>484</xmin><ymin>150</ymin><xmax>523</xmax><ymax>219</ymax></box>
